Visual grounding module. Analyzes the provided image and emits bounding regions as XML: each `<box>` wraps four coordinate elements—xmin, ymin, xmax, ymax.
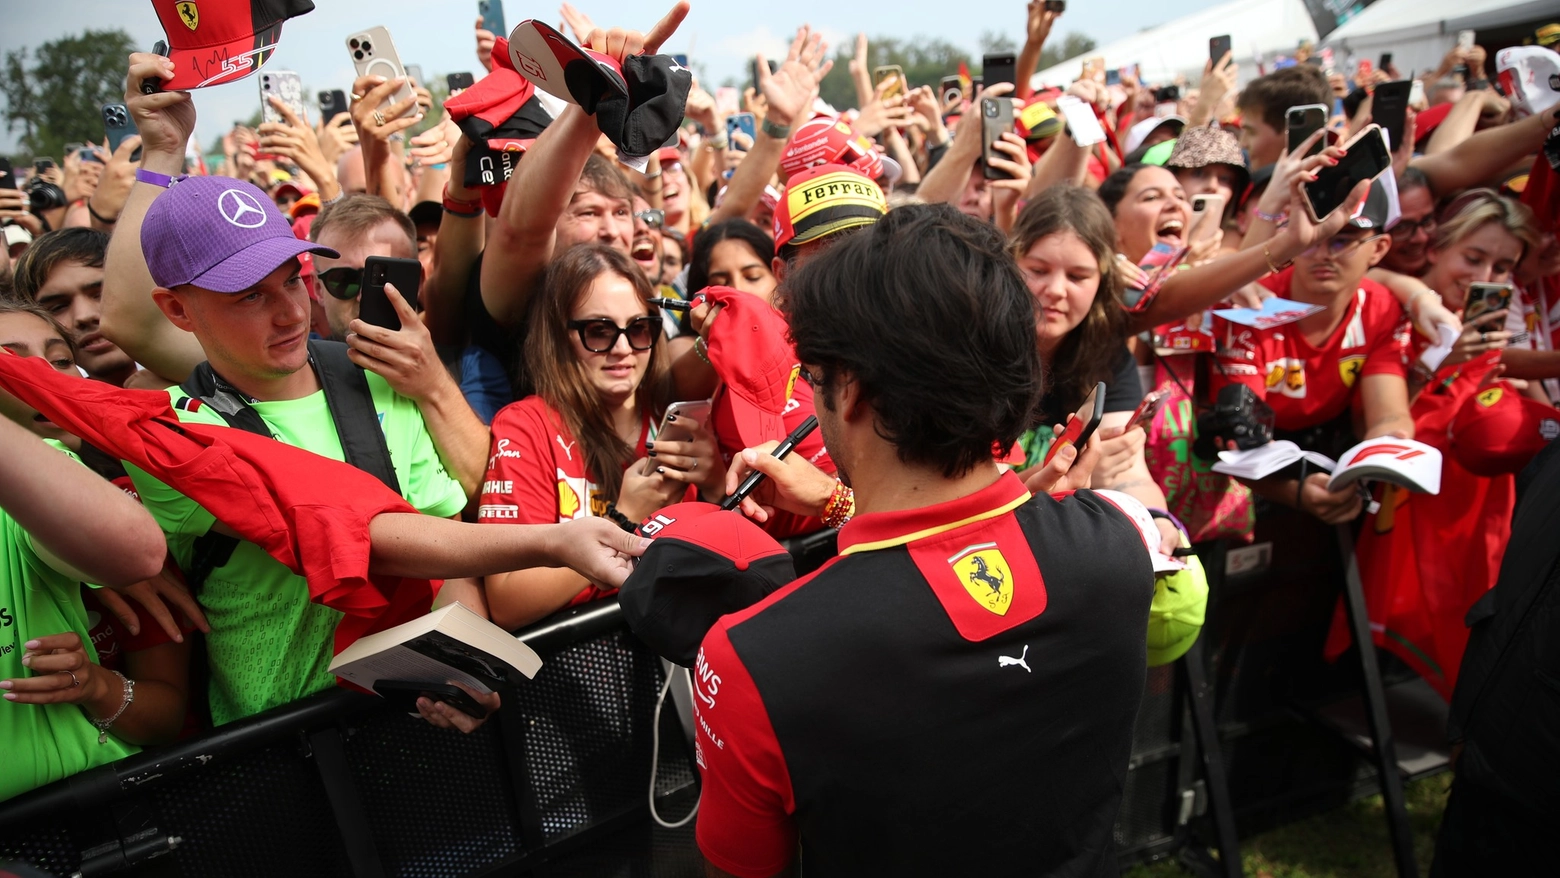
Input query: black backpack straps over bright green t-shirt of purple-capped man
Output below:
<box><xmin>179</xmin><ymin>340</ymin><xmax>401</xmax><ymax>591</ymax></box>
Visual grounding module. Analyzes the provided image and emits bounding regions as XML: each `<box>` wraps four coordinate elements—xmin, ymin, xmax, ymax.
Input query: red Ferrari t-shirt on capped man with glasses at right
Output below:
<box><xmin>1212</xmin><ymin>268</ymin><xmax>1409</xmax><ymax>430</ymax></box>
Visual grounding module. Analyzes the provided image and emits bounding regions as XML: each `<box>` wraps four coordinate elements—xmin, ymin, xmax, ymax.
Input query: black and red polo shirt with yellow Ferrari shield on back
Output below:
<box><xmin>694</xmin><ymin>473</ymin><xmax>1154</xmax><ymax>878</ymax></box>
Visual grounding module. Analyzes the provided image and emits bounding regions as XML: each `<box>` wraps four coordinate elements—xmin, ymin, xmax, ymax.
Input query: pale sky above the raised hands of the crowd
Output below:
<box><xmin>0</xmin><ymin>0</ymin><xmax>1220</xmax><ymax>153</ymax></box>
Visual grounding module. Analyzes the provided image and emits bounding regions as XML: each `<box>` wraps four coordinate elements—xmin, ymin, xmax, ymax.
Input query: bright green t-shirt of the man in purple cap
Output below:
<box><xmin>126</xmin><ymin>373</ymin><xmax>466</xmax><ymax>725</ymax></box>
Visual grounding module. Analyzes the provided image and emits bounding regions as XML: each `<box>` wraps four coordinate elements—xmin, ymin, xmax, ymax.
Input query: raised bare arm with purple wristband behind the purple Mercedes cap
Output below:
<box><xmin>101</xmin><ymin>51</ymin><xmax>206</xmax><ymax>382</ymax></box>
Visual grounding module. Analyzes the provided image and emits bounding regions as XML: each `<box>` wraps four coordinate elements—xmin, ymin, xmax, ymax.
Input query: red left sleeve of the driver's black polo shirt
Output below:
<box><xmin>693</xmin><ymin>622</ymin><xmax>796</xmax><ymax>878</ymax></box>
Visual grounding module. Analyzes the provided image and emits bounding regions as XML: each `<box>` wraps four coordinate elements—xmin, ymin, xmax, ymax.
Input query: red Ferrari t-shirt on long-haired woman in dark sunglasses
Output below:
<box><xmin>477</xmin><ymin>396</ymin><xmax>651</xmax><ymax>607</ymax></box>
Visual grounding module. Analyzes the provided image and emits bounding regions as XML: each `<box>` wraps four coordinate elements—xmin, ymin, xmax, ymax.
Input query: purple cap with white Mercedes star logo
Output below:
<box><xmin>140</xmin><ymin>176</ymin><xmax>340</xmax><ymax>293</ymax></box>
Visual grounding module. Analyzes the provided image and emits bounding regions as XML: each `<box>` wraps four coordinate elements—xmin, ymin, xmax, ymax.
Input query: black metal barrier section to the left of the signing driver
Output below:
<box><xmin>0</xmin><ymin>602</ymin><xmax>694</xmax><ymax>878</ymax></box>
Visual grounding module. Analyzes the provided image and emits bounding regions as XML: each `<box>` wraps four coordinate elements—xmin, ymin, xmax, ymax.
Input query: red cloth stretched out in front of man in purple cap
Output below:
<box><xmin>0</xmin><ymin>352</ymin><xmax>437</xmax><ymax>652</ymax></box>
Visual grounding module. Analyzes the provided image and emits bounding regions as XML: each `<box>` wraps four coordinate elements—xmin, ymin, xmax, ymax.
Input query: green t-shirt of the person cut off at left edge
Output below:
<box><xmin>0</xmin><ymin>441</ymin><xmax>137</xmax><ymax>800</ymax></box>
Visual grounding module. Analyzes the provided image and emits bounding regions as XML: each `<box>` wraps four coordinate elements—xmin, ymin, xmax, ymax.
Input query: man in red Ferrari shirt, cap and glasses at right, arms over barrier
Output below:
<box><xmin>1212</xmin><ymin>181</ymin><xmax>1413</xmax><ymax>524</ymax></box>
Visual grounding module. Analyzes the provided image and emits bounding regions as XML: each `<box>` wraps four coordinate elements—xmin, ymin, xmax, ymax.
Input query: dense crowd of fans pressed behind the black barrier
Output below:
<box><xmin>0</xmin><ymin>0</ymin><xmax>1560</xmax><ymax>873</ymax></box>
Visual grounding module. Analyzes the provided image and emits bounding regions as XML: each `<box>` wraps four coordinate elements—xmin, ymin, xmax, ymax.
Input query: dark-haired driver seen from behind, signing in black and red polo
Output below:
<box><xmin>694</xmin><ymin>204</ymin><xmax>1154</xmax><ymax>878</ymax></box>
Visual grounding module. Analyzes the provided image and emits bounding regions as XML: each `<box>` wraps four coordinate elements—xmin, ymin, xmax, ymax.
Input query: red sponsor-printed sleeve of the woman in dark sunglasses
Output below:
<box><xmin>477</xmin><ymin>398</ymin><xmax>558</xmax><ymax>524</ymax></box>
